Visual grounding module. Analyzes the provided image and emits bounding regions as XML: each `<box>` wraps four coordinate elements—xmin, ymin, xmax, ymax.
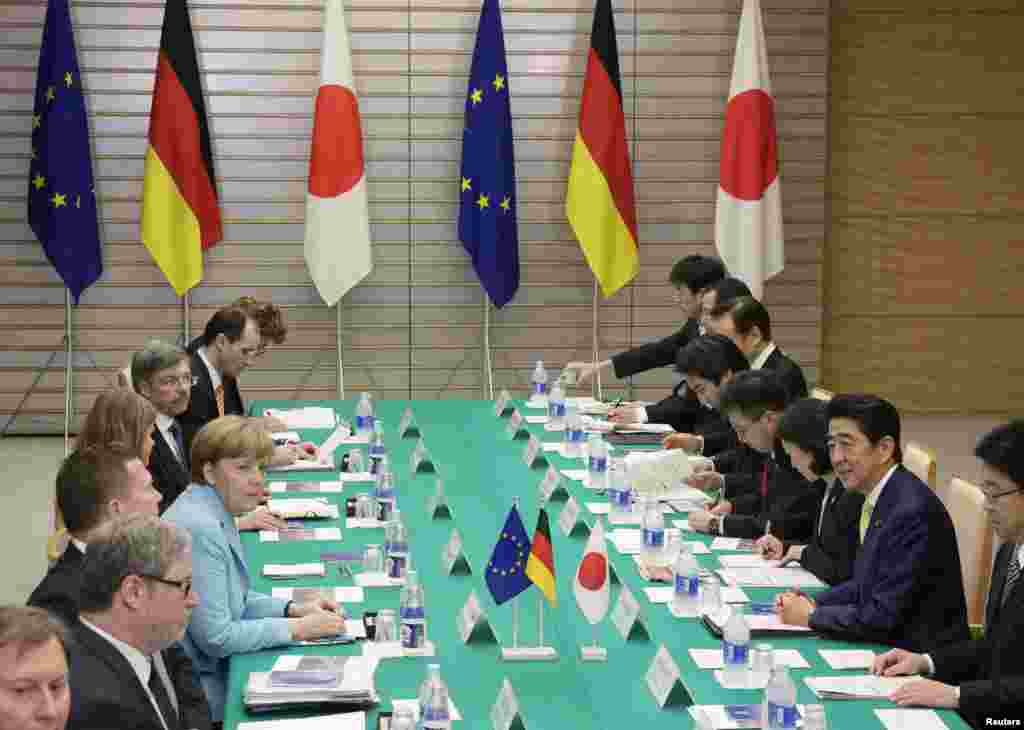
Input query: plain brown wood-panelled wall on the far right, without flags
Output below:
<box><xmin>822</xmin><ymin>0</ymin><xmax>1024</xmax><ymax>415</ymax></box>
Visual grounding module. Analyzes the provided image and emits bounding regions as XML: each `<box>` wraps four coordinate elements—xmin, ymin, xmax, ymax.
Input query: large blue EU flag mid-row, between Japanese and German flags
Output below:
<box><xmin>459</xmin><ymin>0</ymin><xmax>519</xmax><ymax>307</ymax></box>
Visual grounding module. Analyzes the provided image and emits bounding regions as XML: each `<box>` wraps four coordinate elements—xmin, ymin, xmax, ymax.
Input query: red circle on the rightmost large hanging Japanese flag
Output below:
<box><xmin>719</xmin><ymin>89</ymin><xmax>778</xmax><ymax>201</ymax></box>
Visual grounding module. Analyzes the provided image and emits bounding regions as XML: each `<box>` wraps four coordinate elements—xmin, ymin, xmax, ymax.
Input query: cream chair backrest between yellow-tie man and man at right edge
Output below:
<box><xmin>946</xmin><ymin>476</ymin><xmax>995</xmax><ymax>624</ymax></box>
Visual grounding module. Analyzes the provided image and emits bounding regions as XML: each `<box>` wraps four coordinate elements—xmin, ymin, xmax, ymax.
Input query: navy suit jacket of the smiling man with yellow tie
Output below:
<box><xmin>810</xmin><ymin>466</ymin><xmax>968</xmax><ymax>651</ymax></box>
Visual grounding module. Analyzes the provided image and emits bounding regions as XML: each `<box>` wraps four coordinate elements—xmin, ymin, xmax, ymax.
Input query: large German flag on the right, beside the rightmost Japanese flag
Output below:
<box><xmin>565</xmin><ymin>0</ymin><xmax>640</xmax><ymax>297</ymax></box>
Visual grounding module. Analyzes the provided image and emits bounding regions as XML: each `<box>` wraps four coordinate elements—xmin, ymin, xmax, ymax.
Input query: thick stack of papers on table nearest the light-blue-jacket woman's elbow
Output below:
<box><xmin>243</xmin><ymin>655</ymin><xmax>377</xmax><ymax>710</ymax></box>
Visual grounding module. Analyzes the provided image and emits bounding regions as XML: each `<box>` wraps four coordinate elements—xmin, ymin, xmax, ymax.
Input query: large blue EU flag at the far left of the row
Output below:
<box><xmin>29</xmin><ymin>0</ymin><xmax>103</xmax><ymax>304</ymax></box>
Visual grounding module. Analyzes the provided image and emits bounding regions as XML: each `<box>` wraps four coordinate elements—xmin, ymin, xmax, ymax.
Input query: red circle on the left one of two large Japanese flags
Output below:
<box><xmin>309</xmin><ymin>84</ymin><xmax>364</xmax><ymax>198</ymax></box>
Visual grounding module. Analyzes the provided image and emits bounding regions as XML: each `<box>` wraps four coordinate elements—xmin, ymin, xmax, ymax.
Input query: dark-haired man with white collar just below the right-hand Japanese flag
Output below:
<box><xmin>708</xmin><ymin>297</ymin><xmax>807</xmax><ymax>401</ymax></box>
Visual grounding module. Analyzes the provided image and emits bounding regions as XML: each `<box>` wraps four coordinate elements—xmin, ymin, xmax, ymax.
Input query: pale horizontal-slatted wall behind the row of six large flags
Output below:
<box><xmin>0</xmin><ymin>0</ymin><xmax>829</xmax><ymax>431</ymax></box>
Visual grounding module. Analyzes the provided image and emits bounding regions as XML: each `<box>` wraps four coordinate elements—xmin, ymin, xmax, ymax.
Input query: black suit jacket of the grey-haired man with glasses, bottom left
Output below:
<box><xmin>68</xmin><ymin>621</ymin><xmax>210</xmax><ymax>730</ymax></box>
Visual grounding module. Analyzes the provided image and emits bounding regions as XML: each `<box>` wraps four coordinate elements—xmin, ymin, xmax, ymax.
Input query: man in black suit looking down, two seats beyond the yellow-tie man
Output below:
<box><xmin>689</xmin><ymin>372</ymin><xmax>821</xmax><ymax>540</ymax></box>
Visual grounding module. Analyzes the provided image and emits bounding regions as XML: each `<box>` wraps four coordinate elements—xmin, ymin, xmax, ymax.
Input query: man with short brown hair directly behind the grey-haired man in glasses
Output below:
<box><xmin>29</xmin><ymin>448</ymin><xmax>161</xmax><ymax>626</ymax></box>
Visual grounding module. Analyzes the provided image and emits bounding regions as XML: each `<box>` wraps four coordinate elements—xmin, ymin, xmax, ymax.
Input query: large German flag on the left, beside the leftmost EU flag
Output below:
<box><xmin>141</xmin><ymin>0</ymin><xmax>223</xmax><ymax>296</ymax></box>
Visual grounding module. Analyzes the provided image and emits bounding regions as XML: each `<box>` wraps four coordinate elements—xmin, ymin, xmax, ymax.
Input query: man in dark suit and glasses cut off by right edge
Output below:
<box><xmin>874</xmin><ymin>421</ymin><xmax>1024</xmax><ymax>728</ymax></box>
